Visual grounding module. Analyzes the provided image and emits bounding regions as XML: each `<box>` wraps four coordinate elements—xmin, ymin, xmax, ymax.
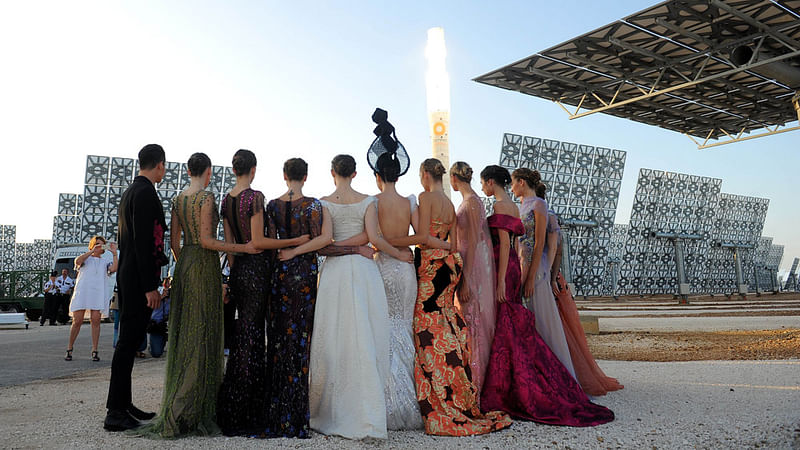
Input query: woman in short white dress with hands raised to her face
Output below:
<box><xmin>64</xmin><ymin>236</ymin><xmax>117</xmax><ymax>361</ymax></box>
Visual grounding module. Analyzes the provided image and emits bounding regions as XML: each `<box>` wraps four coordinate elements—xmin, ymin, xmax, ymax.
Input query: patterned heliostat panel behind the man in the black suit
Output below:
<box><xmin>53</xmin><ymin>155</ymin><xmax>236</xmax><ymax>276</ymax></box>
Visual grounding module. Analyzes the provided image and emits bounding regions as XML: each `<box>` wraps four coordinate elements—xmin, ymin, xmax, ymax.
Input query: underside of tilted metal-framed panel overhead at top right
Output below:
<box><xmin>474</xmin><ymin>0</ymin><xmax>800</xmax><ymax>148</ymax></box>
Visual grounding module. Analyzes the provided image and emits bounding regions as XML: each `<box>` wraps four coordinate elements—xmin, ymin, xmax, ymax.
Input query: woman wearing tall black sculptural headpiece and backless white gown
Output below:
<box><xmin>367</xmin><ymin>109</ymin><xmax>422</xmax><ymax>430</ymax></box>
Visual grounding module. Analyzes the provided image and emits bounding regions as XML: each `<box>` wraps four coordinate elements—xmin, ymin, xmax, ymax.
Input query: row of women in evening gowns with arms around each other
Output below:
<box><xmin>115</xmin><ymin>109</ymin><xmax>622</xmax><ymax>439</ymax></box>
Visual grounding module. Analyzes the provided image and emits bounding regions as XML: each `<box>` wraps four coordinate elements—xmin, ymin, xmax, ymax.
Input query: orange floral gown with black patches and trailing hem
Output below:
<box><xmin>414</xmin><ymin>221</ymin><xmax>511</xmax><ymax>436</ymax></box>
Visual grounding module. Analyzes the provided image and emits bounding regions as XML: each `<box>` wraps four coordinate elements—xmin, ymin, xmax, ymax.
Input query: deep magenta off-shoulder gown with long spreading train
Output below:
<box><xmin>480</xmin><ymin>214</ymin><xmax>614</xmax><ymax>427</ymax></box>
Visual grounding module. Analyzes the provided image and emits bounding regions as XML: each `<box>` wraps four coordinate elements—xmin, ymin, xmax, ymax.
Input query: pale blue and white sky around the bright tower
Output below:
<box><xmin>0</xmin><ymin>0</ymin><xmax>800</xmax><ymax>269</ymax></box>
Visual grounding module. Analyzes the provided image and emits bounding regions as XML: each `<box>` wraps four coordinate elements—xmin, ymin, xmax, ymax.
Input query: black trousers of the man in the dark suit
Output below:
<box><xmin>106</xmin><ymin>277</ymin><xmax>153</xmax><ymax>410</ymax></box>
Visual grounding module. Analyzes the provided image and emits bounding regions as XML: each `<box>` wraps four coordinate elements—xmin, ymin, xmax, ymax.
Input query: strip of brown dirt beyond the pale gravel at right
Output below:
<box><xmin>586</xmin><ymin>329</ymin><xmax>800</xmax><ymax>361</ymax></box>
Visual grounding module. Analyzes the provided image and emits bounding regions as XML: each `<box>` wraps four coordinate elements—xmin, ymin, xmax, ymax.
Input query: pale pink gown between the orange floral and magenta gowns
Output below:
<box><xmin>455</xmin><ymin>196</ymin><xmax>497</xmax><ymax>398</ymax></box>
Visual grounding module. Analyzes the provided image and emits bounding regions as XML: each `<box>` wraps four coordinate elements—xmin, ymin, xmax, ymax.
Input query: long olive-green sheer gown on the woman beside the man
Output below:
<box><xmin>136</xmin><ymin>191</ymin><xmax>223</xmax><ymax>439</ymax></box>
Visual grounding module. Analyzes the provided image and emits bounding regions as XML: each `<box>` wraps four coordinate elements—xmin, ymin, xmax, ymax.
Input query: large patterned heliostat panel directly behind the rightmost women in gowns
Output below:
<box><xmin>500</xmin><ymin>133</ymin><xmax>626</xmax><ymax>296</ymax></box>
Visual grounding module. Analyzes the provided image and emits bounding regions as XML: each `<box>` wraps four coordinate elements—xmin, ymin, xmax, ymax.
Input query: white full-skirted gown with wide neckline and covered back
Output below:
<box><xmin>309</xmin><ymin>197</ymin><xmax>390</xmax><ymax>439</ymax></box>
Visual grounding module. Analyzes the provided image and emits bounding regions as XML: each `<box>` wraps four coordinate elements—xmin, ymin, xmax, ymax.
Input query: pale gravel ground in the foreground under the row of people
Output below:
<box><xmin>0</xmin><ymin>359</ymin><xmax>800</xmax><ymax>449</ymax></box>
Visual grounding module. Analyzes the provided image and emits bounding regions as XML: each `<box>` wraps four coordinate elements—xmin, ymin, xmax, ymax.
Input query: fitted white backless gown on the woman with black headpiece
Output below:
<box><xmin>375</xmin><ymin>195</ymin><xmax>423</xmax><ymax>430</ymax></box>
